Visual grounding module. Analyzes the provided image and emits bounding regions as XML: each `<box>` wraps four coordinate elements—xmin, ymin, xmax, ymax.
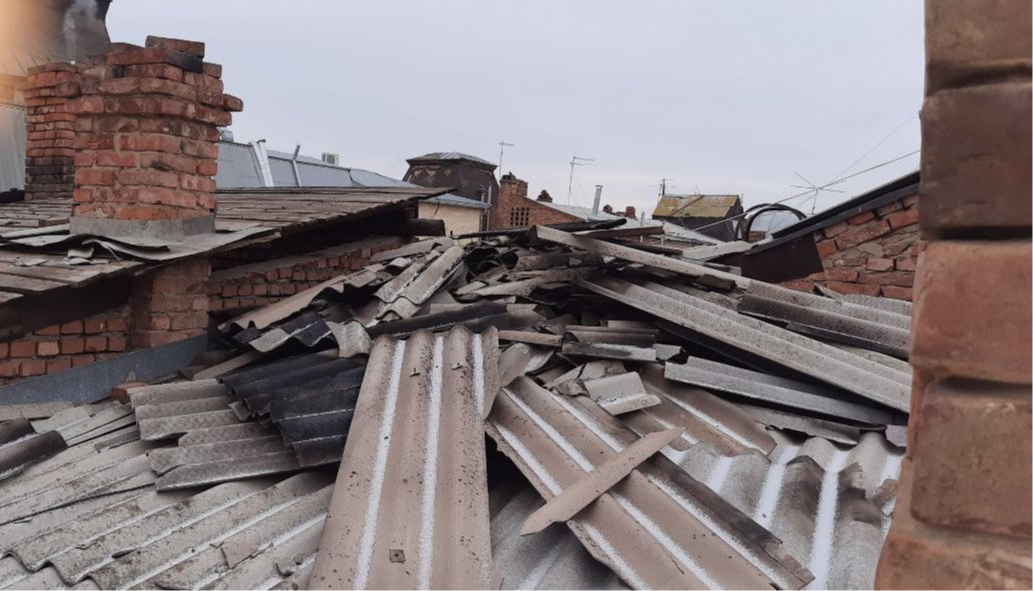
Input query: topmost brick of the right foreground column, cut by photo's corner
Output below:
<box><xmin>926</xmin><ymin>0</ymin><xmax>1033</xmax><ymax>94</ymax></box>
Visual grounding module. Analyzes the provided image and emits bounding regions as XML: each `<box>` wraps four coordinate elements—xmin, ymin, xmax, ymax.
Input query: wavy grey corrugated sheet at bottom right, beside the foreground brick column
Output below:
<box><xmin>668</xmin><ymin>433</ymin><xmax>904</xmax><ymax>591</ymax></box>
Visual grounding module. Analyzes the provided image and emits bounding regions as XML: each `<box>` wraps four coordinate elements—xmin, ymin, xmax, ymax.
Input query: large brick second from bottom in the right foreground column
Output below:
<box><xmin>911</xmin><ymin>380</ymin><xmax>1033</xmax><ymax>538</ymax></box>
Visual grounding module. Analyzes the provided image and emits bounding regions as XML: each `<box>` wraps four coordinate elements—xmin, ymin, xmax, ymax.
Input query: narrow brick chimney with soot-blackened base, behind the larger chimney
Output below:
<box><xmin>22</xmin><ymin>62</ymin><xmax>79</xmax><ymax>199</ymax></box>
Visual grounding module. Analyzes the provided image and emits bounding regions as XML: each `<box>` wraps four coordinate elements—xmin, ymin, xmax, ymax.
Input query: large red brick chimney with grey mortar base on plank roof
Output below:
<box><xmin>56</xmin><ymin>37</ymin><xmax>243</xmax><ymax>242</ymax></box>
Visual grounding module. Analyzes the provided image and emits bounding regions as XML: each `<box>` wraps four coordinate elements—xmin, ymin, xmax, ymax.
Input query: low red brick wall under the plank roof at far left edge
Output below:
<box><xmin>0</xmin><ymin>306</ymin><xmax>129</xmax><ymax>384</ymax></box>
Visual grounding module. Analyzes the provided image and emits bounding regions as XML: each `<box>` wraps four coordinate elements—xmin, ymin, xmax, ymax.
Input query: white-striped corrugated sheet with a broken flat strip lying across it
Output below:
<box><xmin>488</xmin><ymin>378</ymin><xmax>810</xmax><ymax>589</ymax></box>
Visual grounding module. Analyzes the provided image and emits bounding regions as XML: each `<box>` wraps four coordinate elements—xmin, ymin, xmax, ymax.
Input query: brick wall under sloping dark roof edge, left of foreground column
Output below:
<box><xmin>783</xmin><ymin>195</ymin><xmax>922</xmax><ymax>301</ymax></box>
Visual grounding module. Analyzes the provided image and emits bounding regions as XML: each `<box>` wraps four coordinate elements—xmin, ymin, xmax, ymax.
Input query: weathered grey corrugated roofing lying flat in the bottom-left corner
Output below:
<box><xmin>0</xmin><ymin>400</ymin><xmax>333</xmax><ymax>591</ymax></box>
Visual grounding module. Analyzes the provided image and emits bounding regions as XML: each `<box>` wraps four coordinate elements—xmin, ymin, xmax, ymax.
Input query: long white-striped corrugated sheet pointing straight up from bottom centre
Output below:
<box><xmin>312</xmin><ymin>329</ymin><xmax>499</xmax><ymax>590</ymax></box>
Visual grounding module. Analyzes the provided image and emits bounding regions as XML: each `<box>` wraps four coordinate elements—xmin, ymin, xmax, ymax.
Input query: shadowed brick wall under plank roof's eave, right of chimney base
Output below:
<box><xmin>207</xmin><ymin>237</ymin><xmax>403</xmax><ymax>312</ymax></box>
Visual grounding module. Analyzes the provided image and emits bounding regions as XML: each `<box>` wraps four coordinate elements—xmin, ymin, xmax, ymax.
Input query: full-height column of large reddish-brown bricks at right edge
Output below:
<box><xmin>877</xmin><ymin>0</ymin><xmax>1033</xmax><ymax>590</ymax></box>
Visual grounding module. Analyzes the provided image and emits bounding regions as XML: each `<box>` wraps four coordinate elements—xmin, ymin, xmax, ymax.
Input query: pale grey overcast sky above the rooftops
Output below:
<box><xmin>108</xmin><ymin>0</ymin><xmax>924</xmax><ymax>216</ymax></box>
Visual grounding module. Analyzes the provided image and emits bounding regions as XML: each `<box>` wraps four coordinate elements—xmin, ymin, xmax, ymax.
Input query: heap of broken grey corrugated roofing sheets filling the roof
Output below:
<box><xmin>0</xmin><ymin>223</ymin><xmax>910</xmax><ymax>590</ymax></box>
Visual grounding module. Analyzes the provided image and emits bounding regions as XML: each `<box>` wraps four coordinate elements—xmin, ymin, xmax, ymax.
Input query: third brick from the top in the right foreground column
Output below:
<box><xmin>910</xmin><ymin>241</ymin><xmax>1033</xmax><ymax>383</ymax></box>
